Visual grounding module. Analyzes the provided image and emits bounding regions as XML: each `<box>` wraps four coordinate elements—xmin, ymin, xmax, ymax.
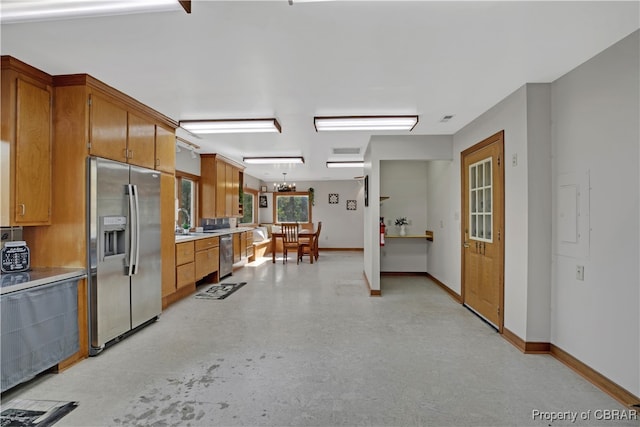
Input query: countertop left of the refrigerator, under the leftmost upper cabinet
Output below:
<box><xmin>0</xmin><ymin>267</ymin><xmax>87</xmax><ymax>295</ymax></box>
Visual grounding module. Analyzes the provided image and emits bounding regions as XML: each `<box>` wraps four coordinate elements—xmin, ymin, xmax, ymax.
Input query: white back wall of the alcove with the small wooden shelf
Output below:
<box><xmin>380</xmin><ymin>160</ymin><xmax>428</xmax><ymax>272</ymax></box>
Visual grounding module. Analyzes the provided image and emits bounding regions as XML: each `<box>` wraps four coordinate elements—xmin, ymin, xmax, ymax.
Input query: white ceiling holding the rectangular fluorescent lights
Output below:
<box><xmin>0</xmin><ymin>0</ymin><xmax>640</xmax><ymax>181</ymax></box>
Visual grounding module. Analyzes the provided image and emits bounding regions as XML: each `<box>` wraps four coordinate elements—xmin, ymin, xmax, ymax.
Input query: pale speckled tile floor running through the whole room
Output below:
<box><xmin>2</xmin><ymin>252</ymin><xmax>638</xmax><ymax>426</ymax></box>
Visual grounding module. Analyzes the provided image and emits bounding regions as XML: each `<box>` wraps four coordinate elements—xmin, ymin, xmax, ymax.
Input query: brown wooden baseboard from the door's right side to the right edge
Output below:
<box><xmin>502</xmin><ymin>328</ymin><xmax>640</xmax><ymax>409</ymax></box>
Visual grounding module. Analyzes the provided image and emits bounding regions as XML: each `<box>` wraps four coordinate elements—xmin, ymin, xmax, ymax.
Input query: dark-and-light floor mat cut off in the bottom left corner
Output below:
<box><xmin>0</xmin><ymin>399</ymin><xmax>78</xmax><ymax>427</ymax></box>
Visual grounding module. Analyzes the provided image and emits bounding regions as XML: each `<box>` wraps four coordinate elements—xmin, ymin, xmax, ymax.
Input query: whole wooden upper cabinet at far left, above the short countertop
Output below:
<box><xmin>0</xmin><ymin>56</ymin><xmax>53</xmax><ymax>226</ymax></box>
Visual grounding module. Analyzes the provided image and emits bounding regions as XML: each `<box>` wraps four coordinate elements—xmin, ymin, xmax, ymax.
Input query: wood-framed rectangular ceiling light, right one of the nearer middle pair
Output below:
<box><xmin>313</xmin><ymin>116</ymin><xmax>418</xmax><ymax>132</ymax></box>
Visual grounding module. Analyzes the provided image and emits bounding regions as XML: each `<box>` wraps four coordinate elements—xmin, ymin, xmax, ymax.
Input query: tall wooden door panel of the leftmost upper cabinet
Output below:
<box><xmin>14</xmin><ymin>79</ymin><xmax>51</xmax><ymax>225</ymax></box>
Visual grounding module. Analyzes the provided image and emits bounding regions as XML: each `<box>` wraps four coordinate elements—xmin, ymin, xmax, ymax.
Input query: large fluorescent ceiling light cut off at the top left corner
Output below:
<box><xmin>1</xmin><ymin>0</ymin><xmax>181</xmax><ymax>23</ymax></box>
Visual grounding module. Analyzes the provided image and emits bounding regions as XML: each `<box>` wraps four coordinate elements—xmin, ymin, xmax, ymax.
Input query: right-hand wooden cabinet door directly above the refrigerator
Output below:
<box><xmin>127</xmin><ymin>113</ymin><xmax>156</xmax><ymax>169</ymax></box>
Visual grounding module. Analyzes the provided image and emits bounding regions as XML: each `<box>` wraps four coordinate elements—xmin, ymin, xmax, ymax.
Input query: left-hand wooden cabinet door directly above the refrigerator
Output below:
<box><xmin>89</xmin><ymin>93</ymin><xmax>127</xmax><ymax>162</ymax></box>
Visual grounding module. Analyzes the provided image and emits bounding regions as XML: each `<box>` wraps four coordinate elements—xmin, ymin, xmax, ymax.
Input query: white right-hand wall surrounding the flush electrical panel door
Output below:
<box><xmin>551</xmin><ymin>31</ymin><xmax>640</xmax><ymax>395</ymax></box>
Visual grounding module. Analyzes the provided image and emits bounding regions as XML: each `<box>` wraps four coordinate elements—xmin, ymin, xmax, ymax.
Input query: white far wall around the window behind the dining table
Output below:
<box><xmin>258</xmin><ymin>179</ymin><xmax>364</xmax><ymax>249</ymax></box>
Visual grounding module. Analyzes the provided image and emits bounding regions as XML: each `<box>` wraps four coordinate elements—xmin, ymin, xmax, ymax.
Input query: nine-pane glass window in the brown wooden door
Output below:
<box><xmin>469</xmin><ymin>157</ymin><xmax>493</xmax><ymax>242</ymax></box>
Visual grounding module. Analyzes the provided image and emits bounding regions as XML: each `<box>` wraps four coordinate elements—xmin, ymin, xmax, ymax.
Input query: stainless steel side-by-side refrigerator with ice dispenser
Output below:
<box><xmin>87</xmin><ymin>157</ymin><xmax>162</xmax><ymax>356</ymax></box>
